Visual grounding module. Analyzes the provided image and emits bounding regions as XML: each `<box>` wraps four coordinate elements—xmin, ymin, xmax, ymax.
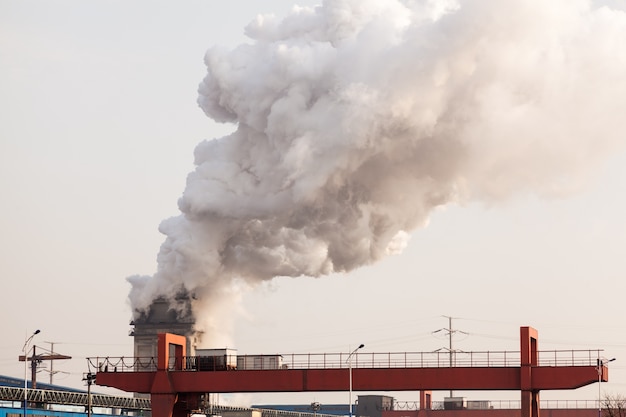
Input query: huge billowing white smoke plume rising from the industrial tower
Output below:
<box><xmin>129</xmin><ymin>0</ymin><xmax>626</xmax><ymax>344</ymax></box>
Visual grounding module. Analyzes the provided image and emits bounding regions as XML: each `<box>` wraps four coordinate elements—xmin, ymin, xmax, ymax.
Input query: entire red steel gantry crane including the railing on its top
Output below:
<box><xmin>88</xmin><ymin>327</ymin><xmax>608</xmax><ymax>417</ymax></box>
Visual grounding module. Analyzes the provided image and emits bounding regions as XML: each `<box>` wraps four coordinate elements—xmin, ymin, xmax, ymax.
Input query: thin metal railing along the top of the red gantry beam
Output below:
<box><xmin>87</xmin><ymin>350</ymin><xmax>601</xmax><ymax>372</ymax></box>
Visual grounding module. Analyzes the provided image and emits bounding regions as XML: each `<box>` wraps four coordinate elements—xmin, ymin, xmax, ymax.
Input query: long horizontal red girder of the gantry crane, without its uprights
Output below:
<box><xmin>96</xmin><ymin>366</ymin><xmax>598</xmax><ymax>394</ymax></box>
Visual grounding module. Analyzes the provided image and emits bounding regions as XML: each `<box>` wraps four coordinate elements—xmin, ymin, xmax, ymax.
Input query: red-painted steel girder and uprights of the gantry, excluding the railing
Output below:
<box><xmin>96</xmin><ymin>327</ymin><xmax>608</xmax><ymax>417</ymax></box>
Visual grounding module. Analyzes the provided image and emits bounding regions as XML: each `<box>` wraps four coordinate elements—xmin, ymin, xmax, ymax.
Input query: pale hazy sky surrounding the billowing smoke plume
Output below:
<box><xmin>0</xmin><ymin>0</ymin><xmax>626</xmax><ymax>403</ymax></box>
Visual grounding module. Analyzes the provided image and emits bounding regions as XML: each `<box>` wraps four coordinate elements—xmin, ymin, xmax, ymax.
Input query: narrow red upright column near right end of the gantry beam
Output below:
<box><xmin>520</xmin><ymin>327</ymin><xmax>540</xmax><ymax>417</ymax></box>
